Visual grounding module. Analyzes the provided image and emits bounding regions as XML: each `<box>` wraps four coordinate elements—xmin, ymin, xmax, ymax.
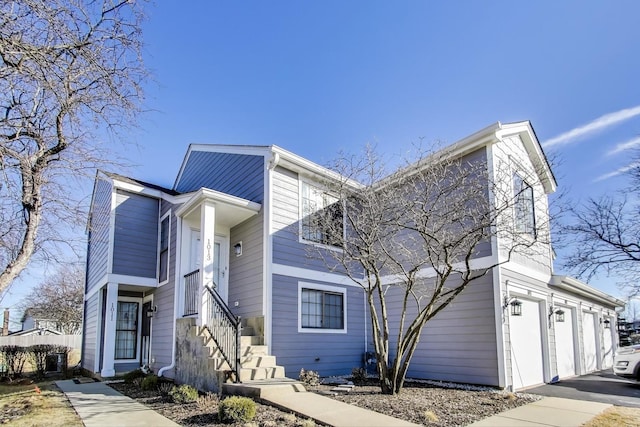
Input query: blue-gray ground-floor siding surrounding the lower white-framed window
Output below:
<box><xmin>271</xmin><ymin>275</ymin><xmax>365</xmax><ymax>378</ymax></box>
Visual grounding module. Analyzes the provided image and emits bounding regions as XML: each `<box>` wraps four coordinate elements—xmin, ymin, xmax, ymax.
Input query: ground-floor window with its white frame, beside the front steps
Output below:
<box><xmin>298</xmin><ymin>282</ymin><xmax>347</xmax><ymax>333</ymax></box>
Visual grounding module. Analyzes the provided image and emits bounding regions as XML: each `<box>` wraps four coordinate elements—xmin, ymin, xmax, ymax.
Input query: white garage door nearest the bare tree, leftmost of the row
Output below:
<box><xmin>509</xmin><ymin>300</ymin><xmax>544</xmax><ymax>390</ymax></box>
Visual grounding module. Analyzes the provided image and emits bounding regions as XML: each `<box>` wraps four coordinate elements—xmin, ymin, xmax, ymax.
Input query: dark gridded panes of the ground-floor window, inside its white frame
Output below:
<box><xmin>300</xmin><ymin>287</ymin><xmax>345</xmax><ymax>330</ymax></box>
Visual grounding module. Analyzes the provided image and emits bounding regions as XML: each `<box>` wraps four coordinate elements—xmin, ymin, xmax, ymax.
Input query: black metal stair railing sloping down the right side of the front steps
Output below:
<box><xmin>205</xmin><ymin>286</ymin><xmax>242</xmax><ymax>383</ymax></box>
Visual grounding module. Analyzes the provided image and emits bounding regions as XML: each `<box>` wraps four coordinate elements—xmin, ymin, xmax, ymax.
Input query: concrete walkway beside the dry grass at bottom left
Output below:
<box><xmin>56</xmin><ymin>380</ymin><xmax>178</xmax><ymax>427</ymax></box>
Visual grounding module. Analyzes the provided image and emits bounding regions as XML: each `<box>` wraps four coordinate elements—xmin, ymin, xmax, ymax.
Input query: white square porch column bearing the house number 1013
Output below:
<box><xmin>198</xmin><ymin>200</ymin><xmax>216</xmax><ymax>326</ymax></box>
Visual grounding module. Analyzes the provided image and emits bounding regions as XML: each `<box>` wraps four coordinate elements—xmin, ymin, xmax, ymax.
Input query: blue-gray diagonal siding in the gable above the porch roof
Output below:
<box><xmin>176</xmin><ymin>151</ymin><xmax>264</xmax><ymax>203</ymax></box>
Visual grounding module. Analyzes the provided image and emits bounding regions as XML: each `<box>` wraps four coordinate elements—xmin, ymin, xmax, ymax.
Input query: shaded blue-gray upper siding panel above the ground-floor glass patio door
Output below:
<box><xmin>113</xmin><ymin>190</ymin><xmax>158</xmax><ymax>277</ymax></box>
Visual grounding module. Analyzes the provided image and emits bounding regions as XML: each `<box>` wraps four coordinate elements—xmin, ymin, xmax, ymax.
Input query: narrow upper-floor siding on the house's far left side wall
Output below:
<box><xmin>86</xmin><ymin>179</ymin><xmax>112</xmax><ymax>292</ymax></box>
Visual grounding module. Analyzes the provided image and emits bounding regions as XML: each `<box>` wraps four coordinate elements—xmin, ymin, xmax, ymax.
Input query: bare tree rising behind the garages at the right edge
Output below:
<box><xmin>560</xmin><ymin>155</ymin><xmax>640</xmax><ymax>295</ymax></box>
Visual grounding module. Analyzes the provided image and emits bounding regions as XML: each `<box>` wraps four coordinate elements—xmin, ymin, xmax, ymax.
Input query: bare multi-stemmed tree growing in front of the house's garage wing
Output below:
<box><xmin>302</xmin><ymin>147</ymin><xmax>549</xmax><ymax>394</ymax></box>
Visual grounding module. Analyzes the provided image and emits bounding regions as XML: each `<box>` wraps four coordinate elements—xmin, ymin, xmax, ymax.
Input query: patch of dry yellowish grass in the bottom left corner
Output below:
<box><xmin>0</xmin><ymin>381</ymin><xmax>83</xmax><ymax>427</ymax></box>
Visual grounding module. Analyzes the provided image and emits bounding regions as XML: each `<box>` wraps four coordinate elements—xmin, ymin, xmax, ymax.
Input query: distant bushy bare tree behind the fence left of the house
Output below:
<box><xmin>21</xmin><ymin>264</ymin><xmax>84</xmax><ymax>335</ymax></box>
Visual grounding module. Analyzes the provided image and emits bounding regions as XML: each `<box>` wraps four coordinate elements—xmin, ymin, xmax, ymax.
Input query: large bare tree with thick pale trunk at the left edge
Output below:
<box><xmin>0</xmin><ymin>0</ymin><xmax>147</xmax><ymax>292</ymax></box>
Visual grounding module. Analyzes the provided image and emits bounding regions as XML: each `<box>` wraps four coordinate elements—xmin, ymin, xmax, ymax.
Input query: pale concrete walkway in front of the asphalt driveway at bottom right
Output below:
<box><xmin>469</xmin><ymin>397</ymin><xmax>612</xmax><ymax>427</ymax></box>
